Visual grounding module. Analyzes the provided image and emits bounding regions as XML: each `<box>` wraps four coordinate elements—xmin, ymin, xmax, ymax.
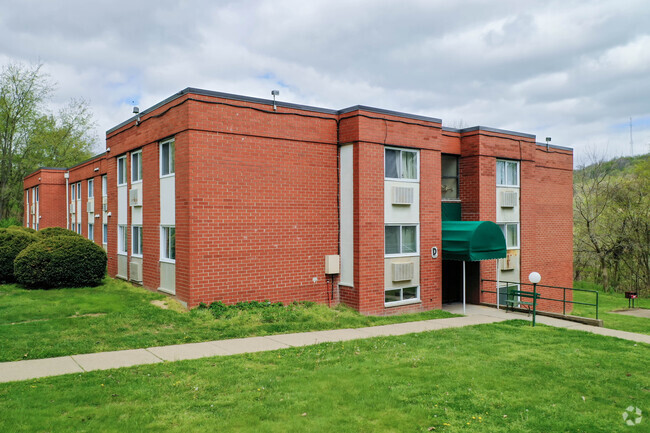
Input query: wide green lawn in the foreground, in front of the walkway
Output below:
<box><xmin>0</xmin><ymin>321</ymin><xmax>650</xmax><ymax>433</ymax></box>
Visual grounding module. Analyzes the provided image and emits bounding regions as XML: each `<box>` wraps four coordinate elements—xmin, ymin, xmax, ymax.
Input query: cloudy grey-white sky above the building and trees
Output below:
<box><xmin>0</xmin><ymin>0</ymin><xmax>650</xmax><ymax>166</ymax></box>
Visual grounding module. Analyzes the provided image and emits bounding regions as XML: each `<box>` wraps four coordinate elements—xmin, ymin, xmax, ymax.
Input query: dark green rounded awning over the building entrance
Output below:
<box><xmin>442</xmin><ymin>221</ymin><xmax>506</xmax><ymax>262</ymax></box>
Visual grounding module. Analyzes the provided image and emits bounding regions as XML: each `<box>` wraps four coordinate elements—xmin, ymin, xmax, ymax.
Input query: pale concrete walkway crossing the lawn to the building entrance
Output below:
<box><xmin>0</xmin><ymin>304</ymin><xmax>650</xmax><ymax>383</ymax></box>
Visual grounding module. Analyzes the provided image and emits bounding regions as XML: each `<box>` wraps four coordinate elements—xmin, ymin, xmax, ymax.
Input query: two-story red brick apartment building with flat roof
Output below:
<box><xmin>24</xmin><ymin>88</ymin><xmax>573</xmax><ymax>314</ymax></box>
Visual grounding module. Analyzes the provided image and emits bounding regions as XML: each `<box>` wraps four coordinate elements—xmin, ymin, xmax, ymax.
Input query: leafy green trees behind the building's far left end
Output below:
<box><xmin>0</xmin><ymin>64</ymin><xmax>95</xmax><ymax>219</ymax></box>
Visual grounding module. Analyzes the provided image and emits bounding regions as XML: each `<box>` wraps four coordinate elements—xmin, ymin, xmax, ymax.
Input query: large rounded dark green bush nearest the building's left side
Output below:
<box><xmin>14</xmin><ymin>236</ymin><xmax>107</xmax><ymax>289</ymax></box>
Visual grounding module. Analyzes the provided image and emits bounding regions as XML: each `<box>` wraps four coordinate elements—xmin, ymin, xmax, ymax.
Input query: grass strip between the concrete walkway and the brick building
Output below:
<box><xmin>0</xmin><ymin>278</ymin><xmax>454</xmax><ymax>362</ymax></box>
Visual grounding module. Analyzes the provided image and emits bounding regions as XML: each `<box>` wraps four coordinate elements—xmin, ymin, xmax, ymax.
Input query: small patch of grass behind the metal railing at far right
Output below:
<box><xmin>571</xmin><ymin>281</ymin><xmax>650</xmax><ymax>335</ymax></box>
